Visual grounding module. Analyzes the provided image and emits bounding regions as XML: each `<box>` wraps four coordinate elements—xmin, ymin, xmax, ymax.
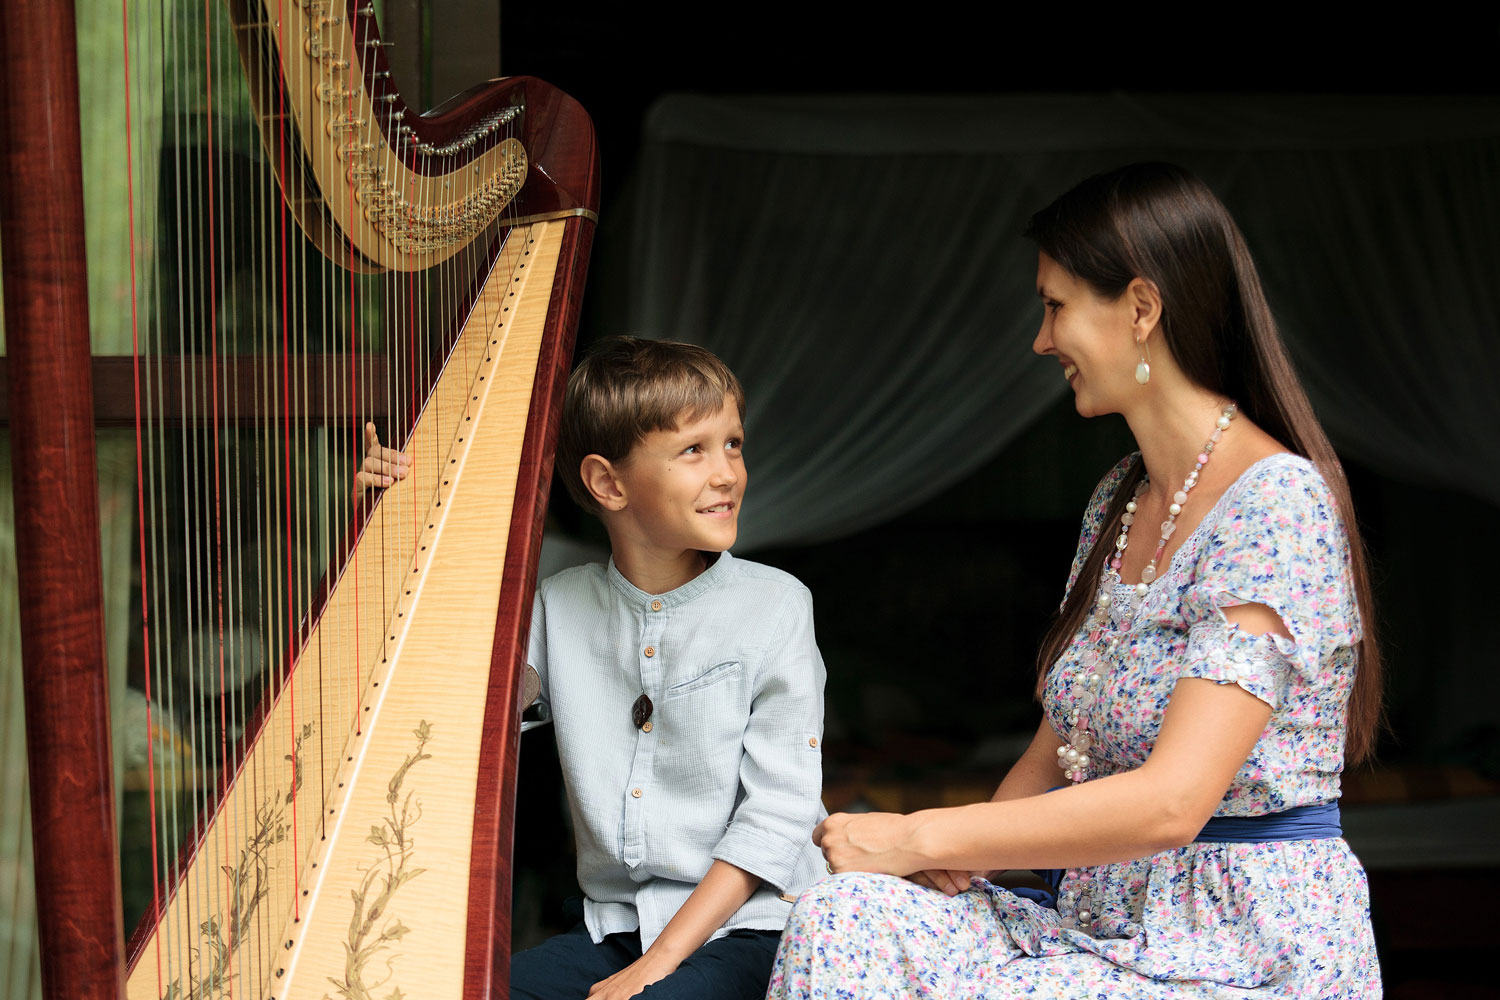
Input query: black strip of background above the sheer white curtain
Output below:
<box><xmin>500</xmin><ymin>10</ymin><xmax>1500</xmax><ymax>235</ymax></box>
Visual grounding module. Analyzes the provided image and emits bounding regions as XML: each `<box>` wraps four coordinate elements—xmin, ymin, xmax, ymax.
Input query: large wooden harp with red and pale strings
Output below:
<box><xmin>0</xmin><ymin>0</ymin><xmax>599</xmax><ymax>1000</ymax></box>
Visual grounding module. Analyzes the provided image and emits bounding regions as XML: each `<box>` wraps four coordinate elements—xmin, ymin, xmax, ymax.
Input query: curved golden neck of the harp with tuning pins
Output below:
<box><xmin>230</xmin><ymin>0</ymin><xmax>597</xmax><ymax>271</ymax></box>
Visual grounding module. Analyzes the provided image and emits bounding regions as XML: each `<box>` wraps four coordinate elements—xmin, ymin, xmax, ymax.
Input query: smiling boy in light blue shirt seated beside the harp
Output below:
<box><xmin>510</xmin><ymin>337</ymin><xmax>825</xmax><ymax>1000</ymax></box>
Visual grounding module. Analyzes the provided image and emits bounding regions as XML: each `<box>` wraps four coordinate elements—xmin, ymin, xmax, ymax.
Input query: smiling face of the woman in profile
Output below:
<box><xmin>1032</xmin><ymin>253</ymin><xmax>1140</xmax><ymax>417</ymax></box>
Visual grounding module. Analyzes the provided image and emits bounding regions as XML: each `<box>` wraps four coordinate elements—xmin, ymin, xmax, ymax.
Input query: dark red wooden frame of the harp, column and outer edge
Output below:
<box><xmin>0</xmin><ymin>0</ymin><xmax>599</xmax><ymax>999</ymax></box>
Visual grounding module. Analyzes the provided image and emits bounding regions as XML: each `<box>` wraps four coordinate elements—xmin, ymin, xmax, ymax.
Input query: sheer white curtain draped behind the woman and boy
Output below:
<box><xmin>591</xmin><ymin>96</ymin><xmax>1500</xmax><ymax>550</ymax></box>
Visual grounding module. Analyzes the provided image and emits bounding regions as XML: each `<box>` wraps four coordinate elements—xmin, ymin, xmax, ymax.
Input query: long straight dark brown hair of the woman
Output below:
<box><xmin>1025</xmin><ymin>163</ymin><xmax>1382</xmax><ymax>763</ymax></box>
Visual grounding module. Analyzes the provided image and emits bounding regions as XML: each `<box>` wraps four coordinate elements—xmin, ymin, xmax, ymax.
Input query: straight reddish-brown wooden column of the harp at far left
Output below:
<box><xmin>0</xmin><ymin>0</ymin><xmax>125</xmax><ymax>1000</ymax></box>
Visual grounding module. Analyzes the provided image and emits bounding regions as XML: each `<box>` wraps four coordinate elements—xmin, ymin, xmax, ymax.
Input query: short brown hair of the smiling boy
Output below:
<box><xmin>558</xmin><ymin>337</ymin><xmax>746</xmax><ymax>514</ymax></box>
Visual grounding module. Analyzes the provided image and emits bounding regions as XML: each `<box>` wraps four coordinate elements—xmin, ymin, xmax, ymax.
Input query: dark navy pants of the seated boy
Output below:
<box><xmin>510</xmin><ymin>924</ymin><xmax>782</xmax><ymax>1000</ymax></box>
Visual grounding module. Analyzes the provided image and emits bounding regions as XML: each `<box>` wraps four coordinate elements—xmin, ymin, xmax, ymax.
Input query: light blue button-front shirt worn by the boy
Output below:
<box><xmin>528</xmin><ymin>552</ymin><xmax>827</xmax><ymax>948</ymax></box>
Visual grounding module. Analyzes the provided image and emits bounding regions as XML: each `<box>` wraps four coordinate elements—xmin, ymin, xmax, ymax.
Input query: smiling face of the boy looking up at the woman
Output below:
<box><xmin>611</xmin><ymin>396</ymin><xmax>746</xmax><ymax>558</ymax></box>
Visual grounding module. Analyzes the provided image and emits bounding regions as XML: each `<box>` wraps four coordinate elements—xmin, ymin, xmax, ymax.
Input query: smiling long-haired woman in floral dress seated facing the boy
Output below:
<box><xmin>770</xmin><ymin>163</ymin><xmax>1380</xmax><ymax>1000</ymax></box>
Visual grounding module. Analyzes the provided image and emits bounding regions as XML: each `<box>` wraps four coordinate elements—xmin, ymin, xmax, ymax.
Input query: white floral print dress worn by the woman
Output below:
<box><xmin>768</xmin><ymin>454</ymin><xmax>1380</xmax><ymax>1000</ymax></box>
